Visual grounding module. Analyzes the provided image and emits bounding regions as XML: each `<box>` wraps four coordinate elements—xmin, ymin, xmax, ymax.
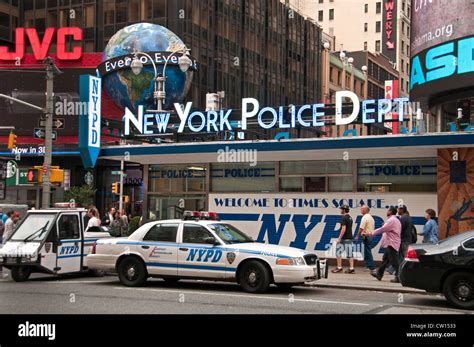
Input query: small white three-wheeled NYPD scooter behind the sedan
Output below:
<box><xmin>0</xmin><ymin>208</ymin><xmax>111</xmax><ymax>282</ymax></box>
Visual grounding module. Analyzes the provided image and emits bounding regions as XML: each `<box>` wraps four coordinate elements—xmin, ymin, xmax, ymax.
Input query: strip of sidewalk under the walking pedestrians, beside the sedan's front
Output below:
<box><xmin>309</xmin><ymin>267</ymin><xmax>426</xmax><ymax>294</ymax></box>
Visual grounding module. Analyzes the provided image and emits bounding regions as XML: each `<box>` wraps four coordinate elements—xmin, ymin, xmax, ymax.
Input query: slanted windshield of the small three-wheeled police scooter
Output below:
<box><xmin>11</xmin><ymin>213</ymin><xmax>56</xmax><ymax>241</ymax></box>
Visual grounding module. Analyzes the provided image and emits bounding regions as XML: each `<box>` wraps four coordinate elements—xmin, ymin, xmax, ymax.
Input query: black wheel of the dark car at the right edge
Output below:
<box><xmin>443</xmin><ymin>272</ymin><xmax>474</xmax><ymax>310</ymax></box>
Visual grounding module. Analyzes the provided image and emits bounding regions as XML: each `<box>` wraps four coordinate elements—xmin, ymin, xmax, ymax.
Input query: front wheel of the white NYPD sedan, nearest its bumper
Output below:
<box><xmin>239</xmin><ymin>260</ymin><xmax>271</xmax><ymax>293</ymax></box>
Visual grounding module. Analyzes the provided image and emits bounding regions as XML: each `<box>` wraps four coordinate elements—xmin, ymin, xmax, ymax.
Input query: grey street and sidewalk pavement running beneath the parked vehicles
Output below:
<box><xmin>0</xmin><ymin>270</ymin><xmax>473</xmax><ymax>314</ymax></box>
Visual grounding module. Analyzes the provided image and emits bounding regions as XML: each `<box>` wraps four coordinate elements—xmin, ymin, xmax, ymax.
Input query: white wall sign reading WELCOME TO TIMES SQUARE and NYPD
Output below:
<box><xmin>209</xmin><ymin>193</ymin><xmax>437</xmax><ymax>260</ymax></box>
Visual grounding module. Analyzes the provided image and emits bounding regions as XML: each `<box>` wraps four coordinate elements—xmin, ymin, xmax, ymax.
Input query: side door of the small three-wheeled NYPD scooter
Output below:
<box><xmin>56</xmin><ymin>212</ymin><xmax>82</xmax><ymax>273</ymax></box>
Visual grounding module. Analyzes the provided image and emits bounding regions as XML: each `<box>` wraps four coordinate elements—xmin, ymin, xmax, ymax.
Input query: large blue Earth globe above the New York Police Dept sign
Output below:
<box><xmin>102</xmin><ymin>23</ymin><xmax>193</xmax><ymax>112</ymax></box>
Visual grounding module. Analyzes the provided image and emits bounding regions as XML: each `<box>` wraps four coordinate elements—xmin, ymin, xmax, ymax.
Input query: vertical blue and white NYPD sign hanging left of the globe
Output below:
<box><xmin>79</xmin><ymin>75</ymin><xmax>102</xmax><ymax>168</ymax></box>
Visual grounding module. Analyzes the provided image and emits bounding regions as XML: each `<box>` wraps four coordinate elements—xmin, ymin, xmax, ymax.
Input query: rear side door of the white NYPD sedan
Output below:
<box><xmin>141</xmin><ymin>223</ymin><xmax>179</xmax><ymax>276</ymax></box>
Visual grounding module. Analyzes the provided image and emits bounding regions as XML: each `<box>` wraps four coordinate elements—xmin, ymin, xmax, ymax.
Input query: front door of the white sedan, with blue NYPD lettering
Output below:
<box><xmin>178</xmin><ymin>223</ymin><xmax>226</xmax><ymax>278</ymax></box>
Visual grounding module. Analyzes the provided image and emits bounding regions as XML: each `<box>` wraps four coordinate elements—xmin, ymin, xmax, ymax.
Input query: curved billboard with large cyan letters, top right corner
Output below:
<box><xmin>410</xmin><ymin>0</ymin><xmax>474</xmax><ymax>101</ymax></box>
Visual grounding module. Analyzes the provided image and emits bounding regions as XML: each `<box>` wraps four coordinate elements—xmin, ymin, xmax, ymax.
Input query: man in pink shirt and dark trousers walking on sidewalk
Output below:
<box><xmin>369</xmin><ymin>206</ymin><xmax>402</xmax><ymax>283</ymax></box>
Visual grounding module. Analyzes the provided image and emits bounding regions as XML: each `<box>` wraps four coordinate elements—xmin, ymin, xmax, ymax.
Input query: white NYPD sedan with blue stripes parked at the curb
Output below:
<box><xmin>87</xmin><ymin>211</ymin><xmax>328</xmax><ymax>293</ymax></box>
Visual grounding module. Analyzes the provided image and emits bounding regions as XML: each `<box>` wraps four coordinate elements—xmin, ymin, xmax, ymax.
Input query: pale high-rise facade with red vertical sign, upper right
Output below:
<box><xmin>290</xmin><ymin>0</ymin><xmax>411</xmax><ymax>95</ymax></box>
